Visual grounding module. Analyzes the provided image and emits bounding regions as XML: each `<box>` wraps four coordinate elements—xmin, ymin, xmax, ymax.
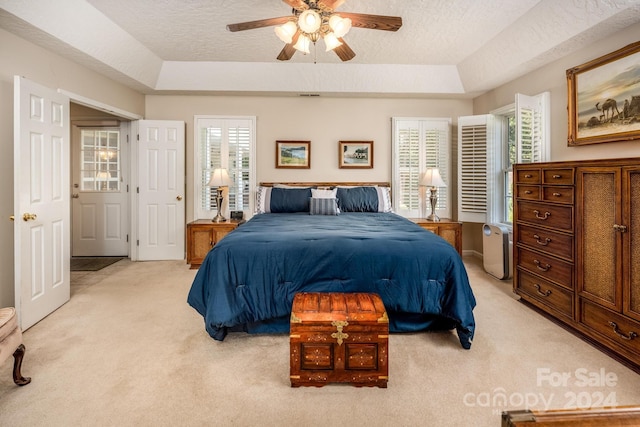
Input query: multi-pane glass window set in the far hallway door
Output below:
<box><xmin>80</xmin><ymin>128</ymin><xmax>122</xmax><ymax>191</ymax></box>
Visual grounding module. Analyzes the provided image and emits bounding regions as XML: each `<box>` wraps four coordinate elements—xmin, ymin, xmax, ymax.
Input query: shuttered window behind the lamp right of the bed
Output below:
<box><xmin>393</xmin><ymin>117</ymin><xmax>451</xmax><ymax>217</ymax></box>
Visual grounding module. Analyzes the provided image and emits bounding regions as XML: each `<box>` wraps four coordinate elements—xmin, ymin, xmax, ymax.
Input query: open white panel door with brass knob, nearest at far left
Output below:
<box><xmin>13</xmin><ymin>76</ymin><xmax>71</xmax><ymax>329</ymax></box>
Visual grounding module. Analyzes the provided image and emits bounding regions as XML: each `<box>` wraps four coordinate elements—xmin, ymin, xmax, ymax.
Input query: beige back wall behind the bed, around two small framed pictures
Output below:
<box><xmin>145</xmin><ymin>95</ymin><xmax>471</xmax><ymax>224</ymax></box>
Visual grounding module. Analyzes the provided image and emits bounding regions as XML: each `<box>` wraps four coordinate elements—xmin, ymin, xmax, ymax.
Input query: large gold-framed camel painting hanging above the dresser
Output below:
<box><xmin>566</xmin><ymin>42</ymin><xmax>640</xmax><ymax>146</ymax></box>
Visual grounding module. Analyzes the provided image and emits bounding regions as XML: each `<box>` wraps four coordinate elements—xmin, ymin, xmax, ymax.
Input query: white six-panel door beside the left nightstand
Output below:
<box><xmin>137</xmin><ymin>120</ymin><xmax>185</xmax><ymax>260</ymax></box>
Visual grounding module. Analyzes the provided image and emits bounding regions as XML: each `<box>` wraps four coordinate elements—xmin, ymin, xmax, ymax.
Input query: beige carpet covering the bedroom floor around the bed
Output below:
<box><xmin>0</xmin><ymin>258</ymin><xmax>640</xmax><ymax>426</ymax></box>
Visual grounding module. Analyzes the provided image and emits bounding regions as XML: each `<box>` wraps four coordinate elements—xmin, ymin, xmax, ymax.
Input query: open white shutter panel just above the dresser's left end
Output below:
<box><xmin>516</xmin><ymin>92</ymin><xmax>550</xmax><ymax>163</ymax></box>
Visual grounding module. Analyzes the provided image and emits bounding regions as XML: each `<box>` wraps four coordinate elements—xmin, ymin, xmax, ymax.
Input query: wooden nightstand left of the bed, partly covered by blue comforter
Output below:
<box><xmin>187</xmin><ymin>219</ymin><xmax>244</xmax><ymax>269</ymax></box>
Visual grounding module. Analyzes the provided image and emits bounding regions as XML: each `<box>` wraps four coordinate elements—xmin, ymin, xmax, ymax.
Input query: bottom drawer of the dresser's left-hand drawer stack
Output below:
<box><xmin>516</xmin><ymin>271</ymin><xmax>573</xmax><ymax>318</ymax></box>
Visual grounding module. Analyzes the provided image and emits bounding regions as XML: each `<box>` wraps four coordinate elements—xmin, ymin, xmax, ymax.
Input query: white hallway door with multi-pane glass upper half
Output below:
<box><xmin>71</xmin><ymin>124</ymin><xmax>129</xmax><ymax>256</ymax></box>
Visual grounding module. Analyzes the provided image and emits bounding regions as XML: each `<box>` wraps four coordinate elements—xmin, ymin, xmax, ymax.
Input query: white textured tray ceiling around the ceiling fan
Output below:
<box><xmin>0</xmin><ymin>0</ymin><xmax>640</xmax><ymax>96</ymax></box>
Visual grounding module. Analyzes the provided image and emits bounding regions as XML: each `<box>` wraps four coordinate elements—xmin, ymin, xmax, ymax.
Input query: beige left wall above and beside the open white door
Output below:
<box><xmin>0</xmin><ymin>29</ymin><xmax>144</xmax><ymax>307</ymax></box>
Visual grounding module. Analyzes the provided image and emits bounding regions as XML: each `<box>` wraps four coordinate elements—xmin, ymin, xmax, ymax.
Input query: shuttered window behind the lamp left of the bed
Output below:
<box><xmin>194</xmin><ymin>116</ymin><xmax>255</xmax><ymax>218</ymax></box>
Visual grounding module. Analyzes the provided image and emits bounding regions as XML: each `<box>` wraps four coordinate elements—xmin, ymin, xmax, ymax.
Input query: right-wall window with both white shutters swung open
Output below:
<box><xmin>458</xmin><ymin>92</ymin><xmax>550</xmax><ymax>225</ymax></box>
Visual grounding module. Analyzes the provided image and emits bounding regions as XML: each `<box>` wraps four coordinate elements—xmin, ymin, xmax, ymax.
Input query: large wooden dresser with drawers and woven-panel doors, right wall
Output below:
<box><xmin>513</xmin><ymin>158</ymin><xmax>640</xmax><ymax>372</ymax></box>
